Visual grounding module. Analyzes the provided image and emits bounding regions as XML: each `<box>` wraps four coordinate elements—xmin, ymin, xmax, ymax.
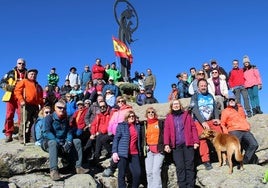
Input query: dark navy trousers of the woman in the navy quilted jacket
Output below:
<box><xmin>117</xmin><ymin>155</ymin><xmax>141</xmax><ymax>188</ymax></box>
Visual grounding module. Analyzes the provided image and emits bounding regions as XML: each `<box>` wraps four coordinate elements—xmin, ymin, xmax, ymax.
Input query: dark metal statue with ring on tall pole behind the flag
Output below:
<box><xmin>114</xmin><ymin>0</ymin><xmax>138</xmax><ymax>81</ymax></box>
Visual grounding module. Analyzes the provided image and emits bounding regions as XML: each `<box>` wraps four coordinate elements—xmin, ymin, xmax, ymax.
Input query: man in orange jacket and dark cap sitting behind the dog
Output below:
<box><xmin>221</xmin><ymin>93</ymin><xmax>259</xmax><ymax>164</ymax></box>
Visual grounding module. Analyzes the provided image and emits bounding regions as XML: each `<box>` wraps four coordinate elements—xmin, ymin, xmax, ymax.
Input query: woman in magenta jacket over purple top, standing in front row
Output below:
<box><xmin>164</xmin><ymin>100</ymin><xmax>199</xmax><ymax>187</ymax></box>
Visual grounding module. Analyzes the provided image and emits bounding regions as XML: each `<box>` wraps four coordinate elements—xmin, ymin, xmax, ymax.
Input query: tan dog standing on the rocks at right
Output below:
<box><xmin>199</xmin><ymin>129</ymin><xmax>244</xmax><ymax>174</ymax></box>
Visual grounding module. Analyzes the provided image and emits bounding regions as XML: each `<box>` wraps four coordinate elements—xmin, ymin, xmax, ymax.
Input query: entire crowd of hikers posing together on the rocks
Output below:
<box><xmin>0</xmin><ymin>57</ymin><xmax>261</xmax><ymax>187</ymax></box>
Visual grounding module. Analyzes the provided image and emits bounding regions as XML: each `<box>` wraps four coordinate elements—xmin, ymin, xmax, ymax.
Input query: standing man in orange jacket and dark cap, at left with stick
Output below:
<box><xmin>14</xmin><ymin>69</ymin><xmax>43</xmax><ymax>144</ymax></box>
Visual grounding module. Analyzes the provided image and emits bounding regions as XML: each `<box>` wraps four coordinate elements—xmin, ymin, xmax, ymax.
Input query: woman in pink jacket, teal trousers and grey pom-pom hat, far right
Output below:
<box><xmin>243</xmin><ymin>55</ymin><xmax>263</xmax><ymax>115</ymax></box>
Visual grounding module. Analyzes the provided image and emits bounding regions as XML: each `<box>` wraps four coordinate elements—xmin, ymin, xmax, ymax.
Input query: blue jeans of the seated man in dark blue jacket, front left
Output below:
<box><xmin>43</xmin><ymin>139</ymin><xmax>82</xmax><ymax>170</ymax></box>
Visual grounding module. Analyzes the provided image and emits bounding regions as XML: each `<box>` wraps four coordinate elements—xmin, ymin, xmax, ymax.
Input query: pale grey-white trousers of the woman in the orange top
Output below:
<box><xmin>145</xmin><ymin>151</ymin><xmax>165</xmax><ymax>188</ymax></box>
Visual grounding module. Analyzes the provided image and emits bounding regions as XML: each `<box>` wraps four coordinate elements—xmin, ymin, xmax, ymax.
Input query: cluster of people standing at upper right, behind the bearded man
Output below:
<box><xmin>168</xmin><ymin>55</ymin><xmax>263</xmax><ymax>117</ymax></box>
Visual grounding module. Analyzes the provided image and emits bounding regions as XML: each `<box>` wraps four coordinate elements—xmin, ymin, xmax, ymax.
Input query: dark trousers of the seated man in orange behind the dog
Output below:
<box><xmin>229</xmin><ymin>131</ymin><xmax>259</xmax><ymax>164</ymax></box>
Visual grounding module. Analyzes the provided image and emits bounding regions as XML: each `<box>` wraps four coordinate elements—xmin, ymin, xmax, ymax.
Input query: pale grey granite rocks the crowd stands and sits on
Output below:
<box><xmin>0</xmin><ymin>99</ymin><xmax>268</xmax><ymax>188</ymax></box>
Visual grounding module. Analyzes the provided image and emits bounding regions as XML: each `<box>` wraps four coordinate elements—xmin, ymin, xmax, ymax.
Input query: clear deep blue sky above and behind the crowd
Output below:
<box><xmin>0</xmin><ymin>0</ymin><xmax>268</xmax><ymax>138</ymax></box>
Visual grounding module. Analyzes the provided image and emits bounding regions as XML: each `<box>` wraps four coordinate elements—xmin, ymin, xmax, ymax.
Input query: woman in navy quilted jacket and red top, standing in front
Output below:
<box><xmin>112</xmin><ymin>110</ymin><xmax>142</xmax><ymax>188</ymax></box>
